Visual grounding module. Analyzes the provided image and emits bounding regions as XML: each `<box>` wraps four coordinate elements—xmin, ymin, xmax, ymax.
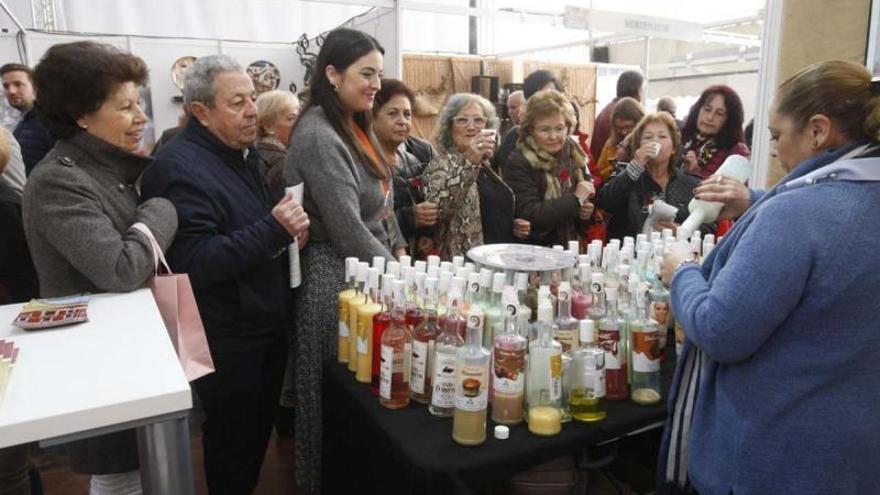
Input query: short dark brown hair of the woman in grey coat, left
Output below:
<box><xmin>34</xmin><ymin>41</ymin><xmax>147</xmax><ymax>139</ymax></box>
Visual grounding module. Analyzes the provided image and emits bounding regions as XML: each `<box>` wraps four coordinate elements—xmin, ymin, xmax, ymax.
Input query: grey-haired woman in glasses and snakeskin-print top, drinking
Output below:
<box><xmin>425</xmin><ymin>93</ymin><xmax>531</xmax><ymax>260</ymax></box>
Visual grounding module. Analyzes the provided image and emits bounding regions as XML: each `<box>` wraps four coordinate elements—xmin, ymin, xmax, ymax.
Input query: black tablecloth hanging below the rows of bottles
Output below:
<box><xmin>322</xmin><ymin>353</ymin><xmax>675</xmax><ymax>494</ymax></box>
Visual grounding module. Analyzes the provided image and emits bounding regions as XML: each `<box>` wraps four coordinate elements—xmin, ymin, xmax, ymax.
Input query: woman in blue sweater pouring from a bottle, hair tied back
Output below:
<box><xmin>658</xmin><ymin>61</ymin><xmax>880</xmax><ymax>495</ymax></box>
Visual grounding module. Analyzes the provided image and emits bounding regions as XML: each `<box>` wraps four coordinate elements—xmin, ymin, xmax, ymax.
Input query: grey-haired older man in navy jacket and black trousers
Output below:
<box><xmin>142</xmin><ymin>55</ymin><xmax>309</xmax><ymax>494</ymax></box>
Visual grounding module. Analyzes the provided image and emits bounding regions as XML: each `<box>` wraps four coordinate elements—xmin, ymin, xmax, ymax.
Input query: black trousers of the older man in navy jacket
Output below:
<box><xmin>194</xmin><ymin>335</ymin><xmax>287</xmax><ymax>495</ymax></box>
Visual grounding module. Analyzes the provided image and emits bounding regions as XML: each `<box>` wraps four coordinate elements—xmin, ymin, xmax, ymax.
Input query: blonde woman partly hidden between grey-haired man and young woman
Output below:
<box><xmin>256</xmin><ymin>89</ymin><xmax>299</xmax><ymax>203</ymax></box>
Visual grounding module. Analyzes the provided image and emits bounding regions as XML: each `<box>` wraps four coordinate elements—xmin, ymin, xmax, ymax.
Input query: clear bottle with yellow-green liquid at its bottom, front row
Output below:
<box><xmin>570</xmin><ymin>319</ymin><xmax>606</xmax><ymax>423</ymax></box>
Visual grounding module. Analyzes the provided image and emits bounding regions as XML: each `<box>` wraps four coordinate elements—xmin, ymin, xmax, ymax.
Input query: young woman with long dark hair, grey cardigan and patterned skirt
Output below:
<box><xmin>284</xmin><ymin>29</ymin><xmax>406</xmax><ymax>492</ymax></box>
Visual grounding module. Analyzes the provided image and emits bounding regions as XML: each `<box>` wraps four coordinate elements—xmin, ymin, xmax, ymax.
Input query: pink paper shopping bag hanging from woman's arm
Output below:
<box><xmin>132</xmin><ymin>223</ymin><xmax>214</xmax><ymax>382</ymax></box>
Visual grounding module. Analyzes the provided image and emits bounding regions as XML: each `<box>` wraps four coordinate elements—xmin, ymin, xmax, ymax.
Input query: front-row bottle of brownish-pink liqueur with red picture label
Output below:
<box><xmin>492</xmin><ymin>313</ymin><xmax>529</xmax><ymax>425</ymax></box>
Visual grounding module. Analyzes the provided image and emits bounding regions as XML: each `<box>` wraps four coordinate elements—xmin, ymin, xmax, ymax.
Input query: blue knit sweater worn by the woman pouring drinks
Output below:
<box><xmin>672</xmin><ymin>143</ymin><xmax>880</xmax><ymax>495</ymax></box>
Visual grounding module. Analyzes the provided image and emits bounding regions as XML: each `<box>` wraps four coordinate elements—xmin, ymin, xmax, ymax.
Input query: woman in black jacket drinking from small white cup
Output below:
<box><xmin>596</xmin><ymin>112</ymin><xmax>712</xmax><ymax>236</ymax></box>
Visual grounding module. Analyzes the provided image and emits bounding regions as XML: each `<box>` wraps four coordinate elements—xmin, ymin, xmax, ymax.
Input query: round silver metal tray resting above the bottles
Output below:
<box><xmin>467</xmin><ymin>244</ymin><xmax>577</xmax><ymax>272</ymax></box>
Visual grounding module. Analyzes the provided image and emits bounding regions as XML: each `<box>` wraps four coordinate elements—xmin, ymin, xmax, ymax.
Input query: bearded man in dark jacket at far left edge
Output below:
<box><xmin>0</xmin><ymin>64</ymin><xmax>55</xmax><ymax>175</ymax></box>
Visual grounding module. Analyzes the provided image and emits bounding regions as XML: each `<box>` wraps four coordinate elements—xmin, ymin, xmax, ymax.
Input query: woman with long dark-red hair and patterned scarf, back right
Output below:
<box><xmin>681</xmin><ymin>85</ymin><xmax>749</xmax><ymax>179</ymax></box>
